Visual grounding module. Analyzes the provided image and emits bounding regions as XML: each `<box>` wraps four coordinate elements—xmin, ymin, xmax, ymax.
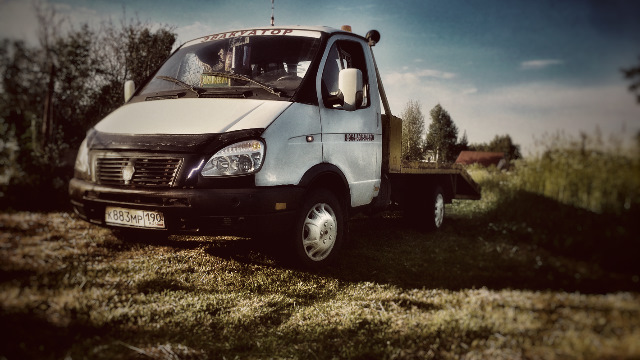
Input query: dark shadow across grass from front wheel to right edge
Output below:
<box><xmin>326</xmin><ymin>192</ymin><xmax>640</xmax><ymax>293</ymax></box>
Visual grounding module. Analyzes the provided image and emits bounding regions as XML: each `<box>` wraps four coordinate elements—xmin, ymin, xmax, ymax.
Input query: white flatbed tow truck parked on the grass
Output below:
<box><xmin>69</xmin><ymin>26</ymin><xmax>480</xmax><ymax>267</ymax></box>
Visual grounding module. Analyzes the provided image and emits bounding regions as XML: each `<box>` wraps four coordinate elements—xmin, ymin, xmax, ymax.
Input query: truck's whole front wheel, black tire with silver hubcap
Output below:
<box><xmin>291</xmin><ymin>189</ymin><xmax>346</xmax><ymax>269</ymax></box>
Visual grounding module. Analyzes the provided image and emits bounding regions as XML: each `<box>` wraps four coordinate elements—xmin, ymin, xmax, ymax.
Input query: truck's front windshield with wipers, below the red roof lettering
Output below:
<box><xmin>140</xmin><ymin>30</ymin><xmax>320</xmax><ymax>99</ymax></box>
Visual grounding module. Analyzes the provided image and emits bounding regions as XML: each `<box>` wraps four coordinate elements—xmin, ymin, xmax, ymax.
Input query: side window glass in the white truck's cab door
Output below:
<box><xmin>321</xmin><ymin>40</ymin><xmax>369</xmax><ymax>108</ymax></box>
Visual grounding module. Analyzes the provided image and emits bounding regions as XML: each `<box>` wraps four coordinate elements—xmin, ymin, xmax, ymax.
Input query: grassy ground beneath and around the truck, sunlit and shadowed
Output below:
<box><xmin>0</xmin><ymin>159</ymin><xmax>640</xmax><ymax>359</ymax></box>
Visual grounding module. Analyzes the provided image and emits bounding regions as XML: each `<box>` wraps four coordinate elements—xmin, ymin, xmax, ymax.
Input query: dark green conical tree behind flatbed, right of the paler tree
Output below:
<box><xmin>426</xmin><ymin>104</ymin><xmax>458</xmax><ymax>164</ymax></box>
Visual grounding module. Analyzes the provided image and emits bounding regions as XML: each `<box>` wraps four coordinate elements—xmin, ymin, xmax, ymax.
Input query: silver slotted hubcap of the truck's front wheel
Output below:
<box><xmin>302</xmin><ymin>203</ymin><xmax>338</xmax><ymax>261</ymax></box>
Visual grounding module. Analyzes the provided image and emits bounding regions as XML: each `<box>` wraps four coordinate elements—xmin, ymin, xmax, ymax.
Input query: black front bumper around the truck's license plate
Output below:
<box><xmin>69</xmin><ymin>179</ymin><xmax>304</xmax><ymax>236</ymax></box>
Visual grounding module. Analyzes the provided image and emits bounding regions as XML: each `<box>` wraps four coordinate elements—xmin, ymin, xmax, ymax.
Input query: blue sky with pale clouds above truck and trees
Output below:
<box><xmin>0</xmin><ymin>0</ymin><xmax>640</xmax><ymax>155</ymax></box>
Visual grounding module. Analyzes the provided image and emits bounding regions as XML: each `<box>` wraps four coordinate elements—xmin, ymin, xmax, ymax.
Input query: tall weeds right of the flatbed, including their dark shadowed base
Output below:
<box><xmin>468</xmin><ymin>134</ymin><xmax>640</xmax><ymax>273</ymax></box>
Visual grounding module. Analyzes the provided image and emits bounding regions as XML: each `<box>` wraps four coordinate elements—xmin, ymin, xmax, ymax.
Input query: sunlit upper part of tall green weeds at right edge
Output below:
<box><xmin>485</xmin><ymin>131</ymin><xmax>640</xmax><ymax>215</ymax></box>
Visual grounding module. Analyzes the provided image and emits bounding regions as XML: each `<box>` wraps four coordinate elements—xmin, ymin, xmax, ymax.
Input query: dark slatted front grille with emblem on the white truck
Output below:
<box><xmin>96</xmin><ymin>156</ymin><xmax>182</xmax><ymax>187</ymax></box>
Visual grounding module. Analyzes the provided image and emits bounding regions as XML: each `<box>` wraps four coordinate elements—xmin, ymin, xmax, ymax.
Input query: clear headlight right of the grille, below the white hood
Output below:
<box><xmin>201</xmin><ymin>140</ymin><xmax>264</xmax><ymax>176</ymax></box>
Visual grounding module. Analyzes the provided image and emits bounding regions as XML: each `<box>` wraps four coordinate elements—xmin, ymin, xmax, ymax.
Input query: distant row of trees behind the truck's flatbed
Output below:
<box><xmin>400</xmin><ymin>100</ymin><xmax>522</xmax><ymax>164</ymax></box>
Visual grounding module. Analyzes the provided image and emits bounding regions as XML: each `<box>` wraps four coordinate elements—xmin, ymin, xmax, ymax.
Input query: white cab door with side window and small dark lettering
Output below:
<box><xmin>317</xmin><ymin>37</ymin><xmax>382</xmax><ymax>206</ymax></box>
